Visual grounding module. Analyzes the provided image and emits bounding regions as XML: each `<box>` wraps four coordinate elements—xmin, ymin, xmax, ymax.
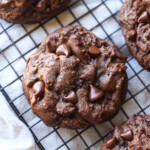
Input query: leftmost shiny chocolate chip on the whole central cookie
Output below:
<box><xmin>33</xmin><ymin>81</ymin><xmax>45</xmax><ymax>96</ymax></box>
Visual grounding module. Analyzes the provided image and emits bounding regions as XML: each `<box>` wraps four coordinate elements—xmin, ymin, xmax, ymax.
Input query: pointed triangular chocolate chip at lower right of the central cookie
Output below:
<box><xmin>89</xmin><ymin>85</ymin><xmax>104</xmax><ymax>102</ymax></box>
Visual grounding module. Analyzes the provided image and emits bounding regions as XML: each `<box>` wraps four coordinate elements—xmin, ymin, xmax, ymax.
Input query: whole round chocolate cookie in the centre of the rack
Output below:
<box><xmin>23</xmin><ymin>26</ymin><xmax>127</xmax><ymax>129</ymax></box>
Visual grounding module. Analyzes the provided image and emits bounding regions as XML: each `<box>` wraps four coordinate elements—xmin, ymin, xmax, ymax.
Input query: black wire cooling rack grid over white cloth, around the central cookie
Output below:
<box><xmin>0</xmin><ymin>0</ymin><xmax>150</xmax><ymax>150</ymax></box>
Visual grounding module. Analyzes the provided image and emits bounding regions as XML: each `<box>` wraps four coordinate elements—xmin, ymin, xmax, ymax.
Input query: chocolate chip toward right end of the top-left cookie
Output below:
<box><xmin>34</xmin><ymin>0</ymin><xmax>47</xmax><ymax>12</ymax></box>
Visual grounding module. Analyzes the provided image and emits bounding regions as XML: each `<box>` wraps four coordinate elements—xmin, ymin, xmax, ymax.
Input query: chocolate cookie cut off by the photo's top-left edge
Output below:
<box><xmin>0</xmin><ymin>0</ymin><xmax>70</xmax><ymax>24</ymax></box>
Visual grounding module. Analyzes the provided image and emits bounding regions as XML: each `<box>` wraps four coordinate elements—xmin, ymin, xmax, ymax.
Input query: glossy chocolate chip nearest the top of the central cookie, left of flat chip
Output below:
<box><xmin>56</xmin><ymin>44</ymin><xmax>70</xmax><ymax>57</ymax></box>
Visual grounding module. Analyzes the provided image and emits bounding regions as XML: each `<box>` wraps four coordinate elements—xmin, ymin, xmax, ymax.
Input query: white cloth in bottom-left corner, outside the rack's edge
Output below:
<box><xmin>0</xmin><ymin>93</ymin><xmax>38</xmax><ymax>150</ymax></box>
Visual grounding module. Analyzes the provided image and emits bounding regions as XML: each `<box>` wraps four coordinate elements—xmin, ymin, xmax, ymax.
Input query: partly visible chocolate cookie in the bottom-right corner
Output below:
<box><xmin>100</xmin><ymin>114</ymin><xmax>150</xmax><ymax>150</ymax></box>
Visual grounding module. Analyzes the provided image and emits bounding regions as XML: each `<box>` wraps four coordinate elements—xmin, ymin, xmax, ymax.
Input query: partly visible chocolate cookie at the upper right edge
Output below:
<box><xmin>119</xmin><ymin>0</ymin><xmax>150</xmax><ymax>71</ymax></box>
